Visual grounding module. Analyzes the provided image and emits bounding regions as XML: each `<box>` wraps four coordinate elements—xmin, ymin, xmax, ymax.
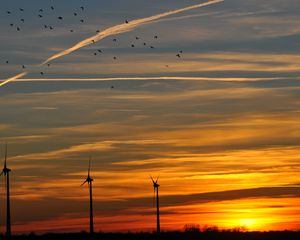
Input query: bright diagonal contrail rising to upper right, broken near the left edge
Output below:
<box><xmin>0</xmin><ymin>0</ymin><xmax>225</xmax><ymax>87</ymax></box>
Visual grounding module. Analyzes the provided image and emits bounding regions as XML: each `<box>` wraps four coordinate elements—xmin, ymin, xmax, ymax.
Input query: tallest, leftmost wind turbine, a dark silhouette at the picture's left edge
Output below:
<box><xmin>0</xmin><ymin>144</ymin><xmax>11</xmax><ymax>237</ymax></box>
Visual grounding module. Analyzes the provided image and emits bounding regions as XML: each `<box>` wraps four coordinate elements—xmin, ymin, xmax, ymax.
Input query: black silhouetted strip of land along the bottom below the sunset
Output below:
<box><xmin>1</xmin><ymin>231</ymin><xmax>300</xmax><ymax>240</ymax></box>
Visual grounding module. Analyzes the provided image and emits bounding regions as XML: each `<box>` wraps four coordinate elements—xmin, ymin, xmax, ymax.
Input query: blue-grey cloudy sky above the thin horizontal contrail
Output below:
<box><xmin>0</xmin><ymin>0</ymin><xmax>299</xmax><ymax>78</ymax></box>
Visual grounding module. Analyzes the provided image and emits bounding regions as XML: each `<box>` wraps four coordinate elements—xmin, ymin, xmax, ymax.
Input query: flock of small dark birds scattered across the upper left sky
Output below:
<box><xmin>5</xmin><ymin>2</ymin><xmax>183</xmax><ymax>76</ymax></box>
